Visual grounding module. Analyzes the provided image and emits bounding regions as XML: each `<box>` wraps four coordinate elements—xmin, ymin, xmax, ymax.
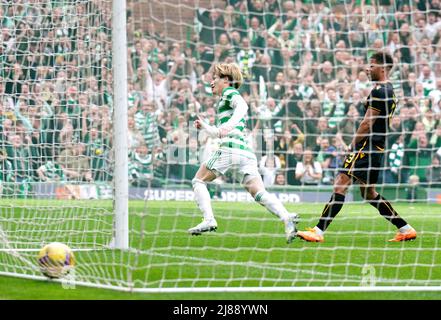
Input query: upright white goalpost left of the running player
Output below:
<box><xmin>112</xmin><ymin>0</ymin><xmax>129</xmax><ymax>250</ymax></box>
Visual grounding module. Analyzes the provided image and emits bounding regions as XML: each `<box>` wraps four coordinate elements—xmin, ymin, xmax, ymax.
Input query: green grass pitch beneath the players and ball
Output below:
<box><xmin>0</xmin><ymin>201</ymin><xmax>441</xmax><ymax>300</ymax></box>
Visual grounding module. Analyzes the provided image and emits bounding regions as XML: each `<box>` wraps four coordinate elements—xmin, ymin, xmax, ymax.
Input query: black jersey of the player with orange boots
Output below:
<box><xmin>357</xmin><ymin>83</ymin><xmax>397</xmax><ymax>150</ymax></box>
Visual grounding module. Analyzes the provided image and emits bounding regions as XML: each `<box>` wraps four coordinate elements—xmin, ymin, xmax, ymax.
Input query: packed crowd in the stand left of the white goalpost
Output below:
<box><xmin>0</xmin><ymin>0</ymin><xmax>112</xmax><ymax>193</ymax></box>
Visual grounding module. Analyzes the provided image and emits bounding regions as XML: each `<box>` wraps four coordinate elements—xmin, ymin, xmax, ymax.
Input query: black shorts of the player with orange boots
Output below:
<box><xmin>340</xmin><ymin>146</ymin><xmax>384</xmax><ymax>184</ymax></box>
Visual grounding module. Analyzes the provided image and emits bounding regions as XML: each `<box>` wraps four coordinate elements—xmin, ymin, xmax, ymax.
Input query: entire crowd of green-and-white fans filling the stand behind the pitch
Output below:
<box><xmin>0</xmin><ymin>0</ymin><xmax>441</xmax><ymax>196</ymax></box>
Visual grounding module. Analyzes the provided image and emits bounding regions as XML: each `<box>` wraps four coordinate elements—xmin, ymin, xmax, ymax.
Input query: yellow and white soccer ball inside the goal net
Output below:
<box><xmin>38</xmin><ymin>242</ymin><xmax>75</xmax><ymax>279</ymax></box>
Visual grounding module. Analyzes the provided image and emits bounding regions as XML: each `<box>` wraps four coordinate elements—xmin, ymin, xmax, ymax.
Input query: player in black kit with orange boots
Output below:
<box><xmin>297</xmin><ymin>52</ymin><xmax>417</xmax><ymax>242</ymax></box>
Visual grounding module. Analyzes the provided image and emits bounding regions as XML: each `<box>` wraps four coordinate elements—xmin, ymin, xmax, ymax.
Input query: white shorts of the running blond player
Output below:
<box><xmin>204</xmin><ymin>148</ymin><xmax>260</xmax><ymax>183</ymax></box>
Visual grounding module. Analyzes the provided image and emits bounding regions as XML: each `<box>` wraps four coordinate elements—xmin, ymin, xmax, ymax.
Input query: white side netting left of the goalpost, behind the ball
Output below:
<box><xmin>0</xmin><ymin>0</ymin><xmax>120</xmax><ymax>282</ymax></box>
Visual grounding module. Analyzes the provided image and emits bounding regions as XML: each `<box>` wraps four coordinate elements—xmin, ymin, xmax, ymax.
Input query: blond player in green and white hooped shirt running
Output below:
<box><xmin>188</xmin><ymin>63</ymin><xmax>297</xmax><ymax>243</ymax></box>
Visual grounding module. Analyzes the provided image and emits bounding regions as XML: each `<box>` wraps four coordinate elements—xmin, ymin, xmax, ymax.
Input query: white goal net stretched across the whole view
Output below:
<box><xmin>0</xmin><ymin>0</ymin><xmax>441</xmax><ymax>292</ymax></box>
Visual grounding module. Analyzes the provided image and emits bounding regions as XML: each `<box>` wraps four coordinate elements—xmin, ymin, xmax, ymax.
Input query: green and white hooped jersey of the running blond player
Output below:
<box><xmin>217</xmin><ymin>87</ymin><xmax>255</xmax><ymax>158</ymax></box>
